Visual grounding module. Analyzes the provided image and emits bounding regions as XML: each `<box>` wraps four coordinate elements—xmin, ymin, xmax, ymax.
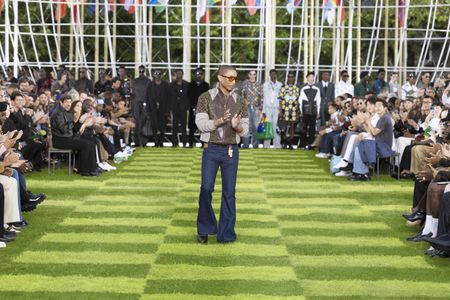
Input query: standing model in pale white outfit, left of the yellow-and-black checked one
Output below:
<box><xmin>263</xmin><ymin>69</ymin><xmax>283</xmax><ymax>149</ymax></box>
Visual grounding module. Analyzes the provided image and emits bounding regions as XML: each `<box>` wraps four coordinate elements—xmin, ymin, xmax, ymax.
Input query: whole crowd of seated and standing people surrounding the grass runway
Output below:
<box><xmin>0</xmin><ymin>66</ymin><xmax>450</xmax><ymax>256</ymax></box>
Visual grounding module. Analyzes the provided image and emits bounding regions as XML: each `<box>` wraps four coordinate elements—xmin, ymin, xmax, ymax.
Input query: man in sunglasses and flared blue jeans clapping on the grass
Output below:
<box><xmin>195</xmin><ymin>65</ymin><xmax>248</xmax><ymax>243</ymax></box>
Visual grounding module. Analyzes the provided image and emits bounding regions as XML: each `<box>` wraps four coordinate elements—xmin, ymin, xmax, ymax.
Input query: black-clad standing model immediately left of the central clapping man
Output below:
<box><xmin>188</xmin><ymin>68</ymin><xmax>209</xmax><ymax>148</ymax></box>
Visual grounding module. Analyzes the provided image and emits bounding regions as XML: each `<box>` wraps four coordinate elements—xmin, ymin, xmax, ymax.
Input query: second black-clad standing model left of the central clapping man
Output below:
<box><xmin>169</xmin><ymin>70</ymin><xmax>189</xmax><ymax>147</ymax></box>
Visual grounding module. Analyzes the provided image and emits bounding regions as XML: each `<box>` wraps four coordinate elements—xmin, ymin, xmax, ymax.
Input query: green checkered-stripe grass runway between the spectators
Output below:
<box><xmin>0</xmin><ymin>149</ymin><xmax>450</xmax><ymax>300</ymax></box>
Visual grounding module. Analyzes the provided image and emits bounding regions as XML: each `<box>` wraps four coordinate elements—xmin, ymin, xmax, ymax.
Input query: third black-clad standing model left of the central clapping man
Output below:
<box><xmin>147</xmin><ymin>69</ymin><xmax>169</xmax><ymax>147</ymax></box>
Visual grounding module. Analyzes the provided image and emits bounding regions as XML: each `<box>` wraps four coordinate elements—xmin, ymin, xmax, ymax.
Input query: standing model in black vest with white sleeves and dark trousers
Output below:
<box><xmin>298</xmin><ymin>72</ymin><xmax>321</xmax><ymax>149</ymax></box>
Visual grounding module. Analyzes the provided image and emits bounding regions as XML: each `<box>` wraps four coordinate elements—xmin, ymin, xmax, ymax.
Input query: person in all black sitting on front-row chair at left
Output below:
<box><xmin>50</xmin><ymin>96</ymin><xmax>99</xmax><ymax>176</ymax></box>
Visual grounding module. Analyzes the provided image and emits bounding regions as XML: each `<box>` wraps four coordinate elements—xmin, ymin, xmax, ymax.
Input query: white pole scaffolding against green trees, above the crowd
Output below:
<box><xmin>0</xmin><ymin>0</ymin><xmax>450</xmax><ymax>81</ymax></box>
